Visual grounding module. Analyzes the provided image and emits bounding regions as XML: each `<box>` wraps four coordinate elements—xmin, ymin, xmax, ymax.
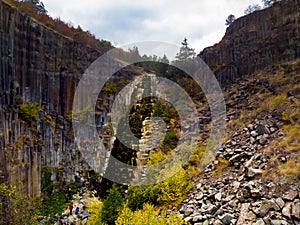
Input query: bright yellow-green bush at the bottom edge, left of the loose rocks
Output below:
<box><xmin>116</xmin><ymin>204</ymin><xmax>189</xmax><ymax>225</ymax></box>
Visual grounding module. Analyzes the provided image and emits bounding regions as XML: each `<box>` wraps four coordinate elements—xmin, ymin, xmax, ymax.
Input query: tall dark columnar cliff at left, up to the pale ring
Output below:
<box><xmin>0</xmin><ymin>1</ymin><xmax>101</xmax><ymax>195</ymax></box>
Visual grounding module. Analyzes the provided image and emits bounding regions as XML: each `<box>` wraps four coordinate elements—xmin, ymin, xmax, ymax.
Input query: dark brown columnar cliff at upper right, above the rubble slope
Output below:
<box><xmin>199</xmin><ymin>0</ymin><xmax>300</xmax><ymax>84</ymax></box>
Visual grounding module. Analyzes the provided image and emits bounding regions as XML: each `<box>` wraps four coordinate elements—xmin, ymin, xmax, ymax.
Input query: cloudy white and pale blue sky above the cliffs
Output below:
<box><xmin>42</xmin><ymin>0</ymin><xmax>261</xmax><ymax>56</ymax></box>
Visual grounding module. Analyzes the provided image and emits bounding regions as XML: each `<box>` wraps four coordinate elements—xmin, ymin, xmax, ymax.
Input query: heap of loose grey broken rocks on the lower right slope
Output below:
<box><xmin>169</xmin><ymin>116</ymin><xmax>300</xmax><ymax>225</ymax></box>
